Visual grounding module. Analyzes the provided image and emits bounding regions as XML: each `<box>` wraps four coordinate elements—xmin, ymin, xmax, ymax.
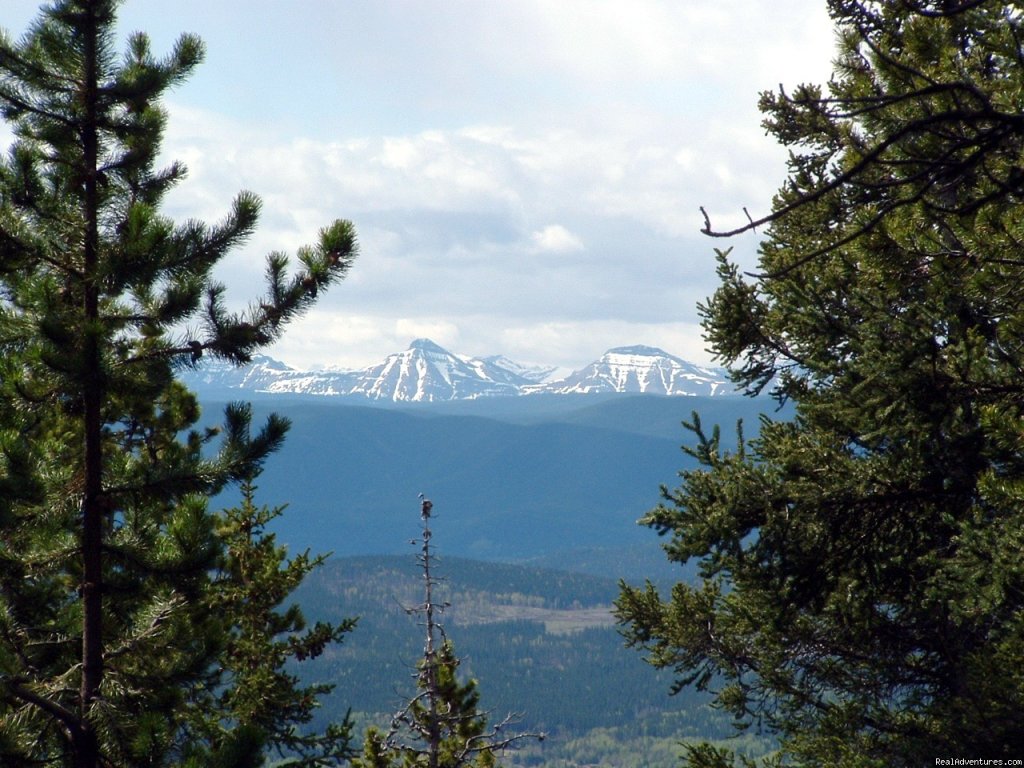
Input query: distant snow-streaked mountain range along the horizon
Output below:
<box><xmin>182</xmin><ymin>339</ymin><xmax>735</xmax><ymax>402</ymax></box>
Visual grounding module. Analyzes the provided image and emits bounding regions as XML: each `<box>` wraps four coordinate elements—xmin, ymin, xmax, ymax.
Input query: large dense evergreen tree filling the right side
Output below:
<box><xmin>617</xmin><ymin>0</ymin><xmax>1024</xmax><ymax>766</ymax></box>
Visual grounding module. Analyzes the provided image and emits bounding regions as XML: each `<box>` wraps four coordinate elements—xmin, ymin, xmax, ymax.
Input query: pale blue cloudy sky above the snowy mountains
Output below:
<box><xmin>0</xmin><ymin>0</ymin><xmax>835</xmax><ymax>369</ymax></box>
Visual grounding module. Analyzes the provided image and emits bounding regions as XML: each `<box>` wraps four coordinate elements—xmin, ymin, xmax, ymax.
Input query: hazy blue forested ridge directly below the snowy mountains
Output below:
<box><xmin>209</xmin><ymin>395</ymin><xmax>772</xmax><ymax>568</ymax></box>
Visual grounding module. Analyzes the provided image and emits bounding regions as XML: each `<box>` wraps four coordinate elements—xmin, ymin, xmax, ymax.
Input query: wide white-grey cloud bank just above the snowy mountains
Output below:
<box><xmin>151</xmin><ymin>113</ymin><xmax>771</xmax><ymax>366</ymax></box>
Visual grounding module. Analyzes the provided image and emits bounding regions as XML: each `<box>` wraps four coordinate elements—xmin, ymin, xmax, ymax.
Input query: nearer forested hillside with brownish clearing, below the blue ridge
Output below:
<box><xmin>297</xmin><ymin>553</ymin><xmax>771</xmax><ymax>766</ymax></box>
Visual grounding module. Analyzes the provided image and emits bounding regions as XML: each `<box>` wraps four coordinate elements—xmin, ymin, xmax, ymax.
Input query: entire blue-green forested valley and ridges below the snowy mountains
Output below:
<box><xmin>193</xmin><ymin>376</ymin><xmax>786</xmax><ymax>768</ymax></box>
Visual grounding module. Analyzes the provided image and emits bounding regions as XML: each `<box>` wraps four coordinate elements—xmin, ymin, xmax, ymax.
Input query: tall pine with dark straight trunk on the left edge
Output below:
<box><xmin>0</xmin><ymin>0</ymin><xmax>355</xmax><ymax>768</ymax></box>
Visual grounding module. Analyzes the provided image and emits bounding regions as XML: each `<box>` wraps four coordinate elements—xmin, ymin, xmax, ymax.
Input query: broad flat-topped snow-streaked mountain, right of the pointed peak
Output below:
<box><xmin>526</xmin><ymin>346</ymin><xmax>732</xmax><ymax>395</ymax></box>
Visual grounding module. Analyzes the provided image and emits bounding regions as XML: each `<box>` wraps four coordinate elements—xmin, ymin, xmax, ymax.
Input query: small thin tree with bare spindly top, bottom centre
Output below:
<box><xmin>352</xmin><ymin>499</ymin><xmax>544</xmax><ymax>768</ymax></box>
